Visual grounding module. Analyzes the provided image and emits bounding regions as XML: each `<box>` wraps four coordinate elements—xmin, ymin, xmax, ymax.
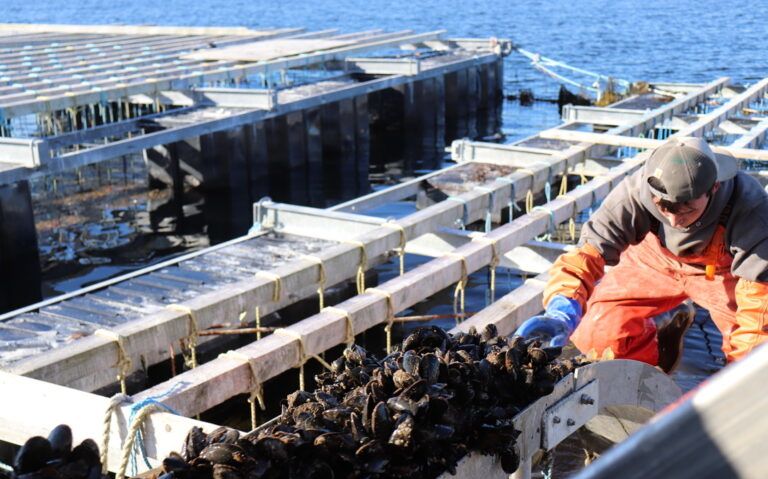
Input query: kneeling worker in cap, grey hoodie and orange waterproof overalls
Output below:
<box><xmin>517</xmin><ymin>138</ymin><xmax>768</xmax><ymax>372</ymax></box>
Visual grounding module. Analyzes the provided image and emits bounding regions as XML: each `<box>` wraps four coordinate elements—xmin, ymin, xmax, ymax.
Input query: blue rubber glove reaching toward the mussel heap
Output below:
<box><xmin>515</xmin><ymin>294</ymin><xmax>581</xmax><ymax>347</ymax></box>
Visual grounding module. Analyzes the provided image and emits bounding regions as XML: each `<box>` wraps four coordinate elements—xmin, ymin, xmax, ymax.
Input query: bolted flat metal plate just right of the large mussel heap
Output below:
<box><xmin>541</xmin><ymin>379</ymin><xmax>600</xmax><ymax>451</ymax></box>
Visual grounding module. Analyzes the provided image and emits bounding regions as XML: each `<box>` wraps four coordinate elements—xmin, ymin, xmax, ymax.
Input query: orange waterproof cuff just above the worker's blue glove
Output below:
<box><xmin>544</xmin><ymin>243</ymin><xmax>605</xmax><ymax>311</ymax></box>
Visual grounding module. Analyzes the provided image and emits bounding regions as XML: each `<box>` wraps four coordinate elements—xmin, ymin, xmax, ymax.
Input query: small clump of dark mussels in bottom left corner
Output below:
<box><xmin>12</xmin><ymin>424</ymin><xmax>102</xmax><ymax>479</ymax></box>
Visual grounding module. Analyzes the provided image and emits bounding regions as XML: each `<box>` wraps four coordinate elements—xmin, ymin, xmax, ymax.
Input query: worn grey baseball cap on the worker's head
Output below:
<box><xmin>644</xmin><ymin>137</ymin><xmax>738</xmax><ymax>203</ymax></box>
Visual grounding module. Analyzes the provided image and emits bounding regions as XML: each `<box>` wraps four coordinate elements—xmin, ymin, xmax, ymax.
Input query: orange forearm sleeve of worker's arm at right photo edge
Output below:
<box><xmin>726</xmin><ymin>278</ymin><xmax>768</xmax><ymax>362</ymax></box>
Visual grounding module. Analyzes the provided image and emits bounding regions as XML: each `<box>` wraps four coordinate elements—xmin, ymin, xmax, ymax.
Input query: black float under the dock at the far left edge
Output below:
<box><xmin>0</xmin><ymin>181</ymin><xmax>41</xmax><ymax>312</ymax></box>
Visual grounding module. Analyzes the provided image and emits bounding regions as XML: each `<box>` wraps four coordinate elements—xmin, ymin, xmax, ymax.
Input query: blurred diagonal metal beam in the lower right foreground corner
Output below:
<box><xmin>574</xmin><ymin>346</ymin><xmax>768</xmax><ymax>479</ymax></box>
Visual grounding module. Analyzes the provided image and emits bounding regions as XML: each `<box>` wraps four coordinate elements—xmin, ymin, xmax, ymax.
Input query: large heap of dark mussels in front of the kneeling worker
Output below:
<box><xmin>161</xmin><ymin>325</ymin><xmax>581</xmax><ymax>479</ymax></box>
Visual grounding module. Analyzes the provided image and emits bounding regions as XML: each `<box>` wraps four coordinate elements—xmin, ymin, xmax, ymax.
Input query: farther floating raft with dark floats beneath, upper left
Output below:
<box><xmin>0</xmin><ymin>25</ymin><xmax>511</xmax><ymax>310</ymax></box>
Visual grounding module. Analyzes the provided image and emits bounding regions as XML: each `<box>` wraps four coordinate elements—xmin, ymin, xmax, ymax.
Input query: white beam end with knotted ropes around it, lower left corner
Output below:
<box><xmin>0</xmin><ymin>372</ymin><xmax>217</xmax><ymax>472</ymax></box>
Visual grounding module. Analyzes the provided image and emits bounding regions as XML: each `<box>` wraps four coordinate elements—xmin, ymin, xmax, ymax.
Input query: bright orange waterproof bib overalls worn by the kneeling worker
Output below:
<box><xmin>571</xmin><ymin>226</ymin><xmax>738</xmax><ymax>365</ymax></box>
